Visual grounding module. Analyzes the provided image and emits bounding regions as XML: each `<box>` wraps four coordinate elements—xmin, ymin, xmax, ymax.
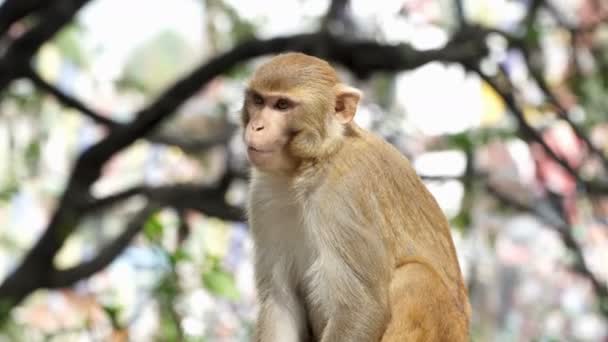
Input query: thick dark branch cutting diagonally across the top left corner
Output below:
<box><xmin>0</xmin><ymin>0</ymin><xmax>89</xmax><ymax>89</ymax></box>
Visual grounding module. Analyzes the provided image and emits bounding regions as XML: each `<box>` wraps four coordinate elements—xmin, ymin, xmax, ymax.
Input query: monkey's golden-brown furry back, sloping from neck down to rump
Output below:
<box><xmin>326</xmin><ymin>125</ymin><xmax>470</xmax><ymax>336</ymax></box>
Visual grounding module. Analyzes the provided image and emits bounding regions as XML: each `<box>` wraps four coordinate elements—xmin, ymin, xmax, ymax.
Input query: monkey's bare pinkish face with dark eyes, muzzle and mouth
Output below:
<box><xmin>243</xmin><ymin>90</ymin><xmax>298</xmax><ymax>173</ymax></box>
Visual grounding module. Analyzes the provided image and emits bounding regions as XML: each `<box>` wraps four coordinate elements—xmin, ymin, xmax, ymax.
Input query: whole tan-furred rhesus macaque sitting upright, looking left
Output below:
<box><xmin>242</xmin><ymin>53</ymin><xmax>470</xmax><ymax>342</ymax></box>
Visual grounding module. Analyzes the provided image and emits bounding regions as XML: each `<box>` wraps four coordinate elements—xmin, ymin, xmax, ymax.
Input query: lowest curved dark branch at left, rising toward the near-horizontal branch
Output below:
<box><xmin>48</xmin><ymin>206</ymin><xmax>156</xmax><ymax>288</ymax></box>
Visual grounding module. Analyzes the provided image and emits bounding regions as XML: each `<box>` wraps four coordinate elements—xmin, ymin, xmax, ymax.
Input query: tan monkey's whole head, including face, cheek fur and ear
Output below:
<box><xmin>242</xmin><ymin>53</ymin><xmax>361</xmax><ymax>173</ymax></box>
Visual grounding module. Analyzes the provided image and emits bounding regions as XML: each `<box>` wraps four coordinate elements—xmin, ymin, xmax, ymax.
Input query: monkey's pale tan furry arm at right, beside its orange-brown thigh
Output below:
<box><xmin>309</xmin><ymin>201</ymin><xmax>391</xmax><ymax>342</ymax></box>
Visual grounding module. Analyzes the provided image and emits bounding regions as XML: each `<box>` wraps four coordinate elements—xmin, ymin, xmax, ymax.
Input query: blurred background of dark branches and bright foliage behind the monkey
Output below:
<box><xmin>0</xmin><ymin>0</ymin><xmax>608</xmax><ymax>341</ymax></box>
